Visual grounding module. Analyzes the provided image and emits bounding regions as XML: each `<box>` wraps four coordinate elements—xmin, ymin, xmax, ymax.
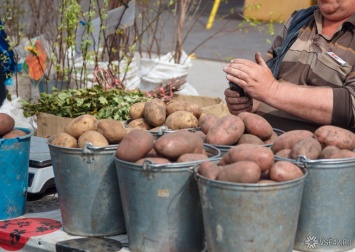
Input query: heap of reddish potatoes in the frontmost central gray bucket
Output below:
<box><xmin>198</xmin><ymin>144</ymin><xmax>304</xmax><ymax>184</ymax></box>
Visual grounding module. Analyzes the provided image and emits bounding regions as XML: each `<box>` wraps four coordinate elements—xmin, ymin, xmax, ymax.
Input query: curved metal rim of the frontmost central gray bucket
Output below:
<box><xmin>195</xmin><ymin>168</ymin><xmax>308</xmax><ymax>190</ymax></box>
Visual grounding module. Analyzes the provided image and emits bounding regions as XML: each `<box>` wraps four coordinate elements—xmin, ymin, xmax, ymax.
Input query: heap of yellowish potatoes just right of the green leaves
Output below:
<box><xmin>128</xmin><ymin>98</ymin><xmax>202</xmax><ymax>130</ymax></box>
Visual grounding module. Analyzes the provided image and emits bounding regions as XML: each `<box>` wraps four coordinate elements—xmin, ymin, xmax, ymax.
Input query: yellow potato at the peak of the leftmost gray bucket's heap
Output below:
<box><xmin>64</xmin><ymin>114</ymin><xmax>98</xmax><ymax>139</ymax></box>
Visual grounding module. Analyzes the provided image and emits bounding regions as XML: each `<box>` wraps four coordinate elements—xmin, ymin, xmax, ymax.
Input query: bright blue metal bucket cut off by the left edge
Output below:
<box><xmin>0</xmin><ymin>127</ymin><xmax>33</xmax><ymax>220</ymax></box>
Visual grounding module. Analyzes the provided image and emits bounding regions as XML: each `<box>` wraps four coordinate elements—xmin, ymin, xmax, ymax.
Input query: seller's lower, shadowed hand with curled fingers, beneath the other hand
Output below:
<box><xmin>224</xmin><ymin>88</ymin><xmax>254</xmax><ymax>115</ymax></box>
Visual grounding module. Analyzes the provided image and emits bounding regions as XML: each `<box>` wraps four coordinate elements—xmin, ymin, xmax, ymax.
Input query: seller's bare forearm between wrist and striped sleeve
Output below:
<box><xmin>261</xmin><ymin>82</ymin><xmax>333</xmax><ymax>124</ymax></box>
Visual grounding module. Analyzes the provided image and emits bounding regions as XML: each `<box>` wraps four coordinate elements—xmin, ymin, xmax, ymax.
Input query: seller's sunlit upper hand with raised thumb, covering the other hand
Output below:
<box><xmin>223</xmin><ymin>52</ymin><xmax>279</xmax><ymax>101</ymax></box>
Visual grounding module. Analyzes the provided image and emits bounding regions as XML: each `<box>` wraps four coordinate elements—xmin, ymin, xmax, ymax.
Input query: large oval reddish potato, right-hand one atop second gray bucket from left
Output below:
<box><xmin>154</xmin><ymin>130</ymin><xmax>203</xmax><ymax>161</ymax></box>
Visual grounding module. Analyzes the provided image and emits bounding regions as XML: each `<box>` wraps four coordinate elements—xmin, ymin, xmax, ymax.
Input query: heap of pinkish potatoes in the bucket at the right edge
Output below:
<box><xmin>271</xmin><ymin>125</ymin><xmax>355</xmax><ymax>160</ymax></box>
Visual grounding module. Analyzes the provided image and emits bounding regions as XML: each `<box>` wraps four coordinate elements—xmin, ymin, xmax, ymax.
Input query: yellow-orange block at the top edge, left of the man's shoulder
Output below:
<box><xmin>243</xmin><ymin>0</ymin><xmax>314</xmax><ymax>22</ymax></box>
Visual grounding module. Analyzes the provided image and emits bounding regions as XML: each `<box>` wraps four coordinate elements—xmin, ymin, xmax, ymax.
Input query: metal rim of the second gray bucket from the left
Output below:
<box><xmin>115</xmin><ymin>144</ymin><xmax>221</xmax><ymax>171</ymax></box>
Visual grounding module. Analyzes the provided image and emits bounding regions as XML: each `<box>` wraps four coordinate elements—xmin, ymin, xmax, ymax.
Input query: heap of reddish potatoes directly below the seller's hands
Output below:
<box><xmin>199</xmin><ymin>112</ymin><xmax>278</xmax><ymax>146</ymax></box>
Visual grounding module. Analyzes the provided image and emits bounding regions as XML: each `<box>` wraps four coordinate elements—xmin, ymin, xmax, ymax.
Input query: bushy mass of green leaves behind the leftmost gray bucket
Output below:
<box><xmin>22</xmin><ymin>85</ymin><xmax>150</xmax><ymax>121</ymax></box>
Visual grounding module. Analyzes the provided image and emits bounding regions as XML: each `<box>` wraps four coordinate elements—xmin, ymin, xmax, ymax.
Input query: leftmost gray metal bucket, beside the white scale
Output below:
<box><xmin>47</xmin><ymin>137</ymin><xmax>126</xmax><ymax>237</ymax></box>
